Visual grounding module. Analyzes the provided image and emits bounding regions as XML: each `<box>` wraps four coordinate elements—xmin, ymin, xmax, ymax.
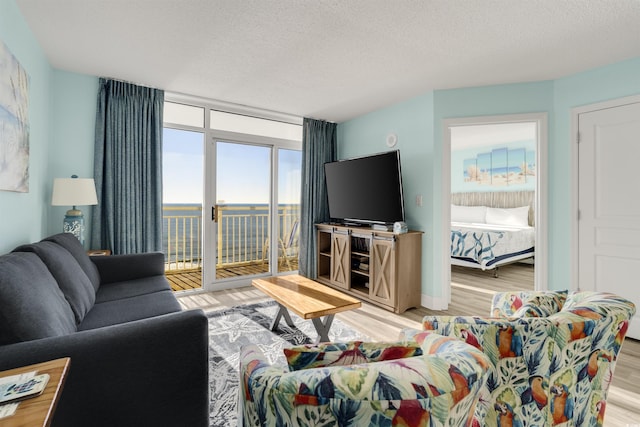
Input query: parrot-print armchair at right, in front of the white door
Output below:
<box><xmin>401</xmin><ymin>291</ymin><xmax>635</xmax><ymax>427</ymax></box>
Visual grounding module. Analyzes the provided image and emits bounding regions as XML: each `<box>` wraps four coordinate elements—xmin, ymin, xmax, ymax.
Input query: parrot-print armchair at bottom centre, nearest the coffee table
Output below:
<box><xmin>240</xmin><ymin>334</ymin><xmax>489</xmax><ymax>427</ymax></box>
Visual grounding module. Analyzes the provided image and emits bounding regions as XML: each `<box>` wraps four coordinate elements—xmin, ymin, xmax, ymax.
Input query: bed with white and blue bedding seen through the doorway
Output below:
<box><xmin>451</xmin><ymin>196</ymin><xmax>536</xmax><ymax>277</ymax></box>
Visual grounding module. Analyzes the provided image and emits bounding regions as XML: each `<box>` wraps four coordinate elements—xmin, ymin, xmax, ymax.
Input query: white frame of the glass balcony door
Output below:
<box><xmin>202</xmin><ymin>129</ymin><xmax>302</xmax><ymax>291</ymax></box>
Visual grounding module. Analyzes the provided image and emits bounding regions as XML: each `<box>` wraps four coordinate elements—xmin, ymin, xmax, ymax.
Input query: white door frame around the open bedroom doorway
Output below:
<box><xmin>441</xmin><ymin>112</ymin><xmax>549</xmax><ymax>304</ymax></box>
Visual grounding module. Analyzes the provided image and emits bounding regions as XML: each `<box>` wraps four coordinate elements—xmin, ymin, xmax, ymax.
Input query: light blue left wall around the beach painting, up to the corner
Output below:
<box><xmin>0</xmin><ymin>0</ymin><xmax>52</xmax><ymax>253</ymax></box>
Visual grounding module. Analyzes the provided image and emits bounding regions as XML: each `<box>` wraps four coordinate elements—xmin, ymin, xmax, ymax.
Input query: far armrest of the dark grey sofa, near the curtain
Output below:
<box><xmin>91</xmin><ymin>252</ymin><xmax>164</xmax><ymax>284</ymax></box>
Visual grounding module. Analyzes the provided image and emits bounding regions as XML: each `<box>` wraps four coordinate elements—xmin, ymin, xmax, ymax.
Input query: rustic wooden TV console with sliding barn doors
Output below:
<box><xmin>316</xmin><ymin>224</ymin><xmax>422</xmax><ymax>313</ymax></box>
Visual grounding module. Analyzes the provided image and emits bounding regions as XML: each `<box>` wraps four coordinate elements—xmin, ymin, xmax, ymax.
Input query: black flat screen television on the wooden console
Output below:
<box><xmin>324</xmin><ymin>150</ymin><xmax>404</xmax><ymax>224</ymax></box>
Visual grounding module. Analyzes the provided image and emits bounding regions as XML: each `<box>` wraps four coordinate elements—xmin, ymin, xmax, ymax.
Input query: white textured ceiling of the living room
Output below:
<box><xmin>16</xmin><ymin>0</ymin><xmax>640</xmax><ymax>122</ymax></box>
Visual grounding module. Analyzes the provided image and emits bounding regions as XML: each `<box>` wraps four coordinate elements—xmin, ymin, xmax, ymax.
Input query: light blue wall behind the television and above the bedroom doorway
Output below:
<box><xmin>338</xmin><ymin>82</ymin><xmax>553</xmax><ymax>300</ymax></box>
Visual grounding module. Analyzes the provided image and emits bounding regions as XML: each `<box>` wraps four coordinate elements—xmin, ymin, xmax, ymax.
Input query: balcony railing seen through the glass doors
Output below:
<box><xmin>163</xmin><ymin>205</ymin><xmax>300</xmax><ymax>271</ymax></box>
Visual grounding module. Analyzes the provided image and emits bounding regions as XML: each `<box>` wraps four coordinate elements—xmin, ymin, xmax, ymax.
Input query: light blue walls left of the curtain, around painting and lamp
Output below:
<box><xmin>0</xmin><ymin>0</ymin><xmax>98</xmax><ymax>254</ymax></box>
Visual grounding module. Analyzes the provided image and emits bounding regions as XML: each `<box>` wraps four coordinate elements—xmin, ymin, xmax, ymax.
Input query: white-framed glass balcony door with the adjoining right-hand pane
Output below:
<box><xmin>205</xmin><ymin>136</ymin><xmax>301</xmax><ymax>290</ymax></box>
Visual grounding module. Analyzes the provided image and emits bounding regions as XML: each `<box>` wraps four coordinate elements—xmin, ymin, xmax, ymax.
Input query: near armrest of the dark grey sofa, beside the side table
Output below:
<box><xmin>0</xmin><ymin>310</ymin><xmax>209</xmax><ymax>426</ymax></box>
